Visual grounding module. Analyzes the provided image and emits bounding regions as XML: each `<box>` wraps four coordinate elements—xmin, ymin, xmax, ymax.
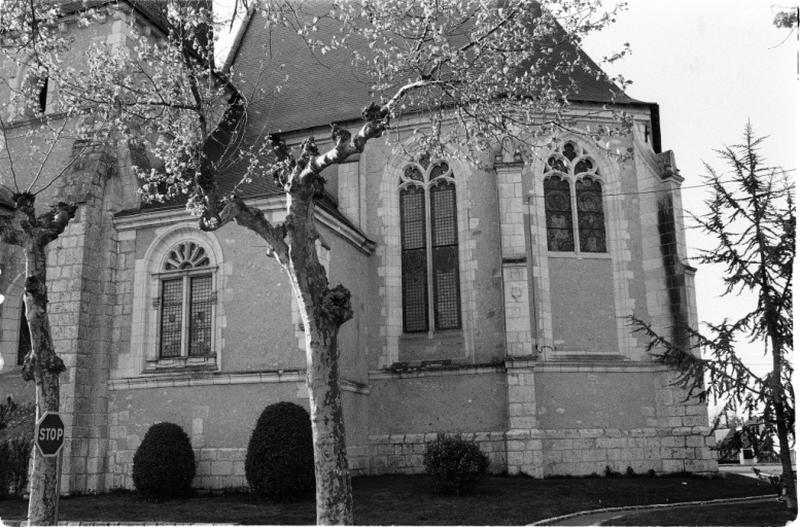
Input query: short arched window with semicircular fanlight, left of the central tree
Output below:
<box><xmin>157</xmin><ymin>241</ymin><xmax>216</xmax><ymax>359</ymax></box>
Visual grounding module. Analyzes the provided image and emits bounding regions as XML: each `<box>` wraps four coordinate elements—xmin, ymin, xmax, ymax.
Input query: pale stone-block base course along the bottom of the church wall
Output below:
<box><xmin>101</xmin><ymin>426</ymin><xmax>717</xmax><ymax>489</ymax></box>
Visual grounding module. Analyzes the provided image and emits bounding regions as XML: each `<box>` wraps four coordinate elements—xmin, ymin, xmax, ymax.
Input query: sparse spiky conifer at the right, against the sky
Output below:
<box><xmin>633</xmin><ymin>124</ymin><xmax>797</xmax><ymax>509</ymax></box>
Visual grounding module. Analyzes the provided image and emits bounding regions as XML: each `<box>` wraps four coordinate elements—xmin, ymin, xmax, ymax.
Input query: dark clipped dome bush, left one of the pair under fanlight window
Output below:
<box><xmin>133</xmin><ymin>423</ymin><xmax>195</xmax><ymax>499</ymax></box>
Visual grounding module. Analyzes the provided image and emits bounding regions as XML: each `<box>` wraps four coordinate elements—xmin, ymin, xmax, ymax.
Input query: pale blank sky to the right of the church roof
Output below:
<box><xmin>584</xmin><ymin>0</ymin><xmax>800</xmax><ymax>380</ymax></box>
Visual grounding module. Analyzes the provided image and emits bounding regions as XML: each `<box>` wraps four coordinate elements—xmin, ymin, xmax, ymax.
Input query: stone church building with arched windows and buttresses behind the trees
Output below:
<box><xmin>0</xmin><ymin>1</ymin><xmax>716</xmax><ymax>492</ymax></box>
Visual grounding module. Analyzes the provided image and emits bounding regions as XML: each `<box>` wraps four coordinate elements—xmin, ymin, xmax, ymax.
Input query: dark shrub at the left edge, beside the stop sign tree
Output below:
<box><xmin>0</xmin><ymin>397</ymin><xmax>36</xmax><ymax>498</ymax></box>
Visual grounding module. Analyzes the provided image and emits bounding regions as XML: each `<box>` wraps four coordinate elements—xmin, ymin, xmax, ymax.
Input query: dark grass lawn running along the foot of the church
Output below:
<box><xmin>0</xmin><ymin>474</ymin><xmax>772</xmax><ymax>525</ymax></box>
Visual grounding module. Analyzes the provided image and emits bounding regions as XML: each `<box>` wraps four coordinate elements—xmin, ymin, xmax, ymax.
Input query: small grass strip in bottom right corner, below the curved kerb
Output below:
<box><xmin>608</xmin><ymin>500</ymin><xmax>797</xmax><ymax>527</ymax></box>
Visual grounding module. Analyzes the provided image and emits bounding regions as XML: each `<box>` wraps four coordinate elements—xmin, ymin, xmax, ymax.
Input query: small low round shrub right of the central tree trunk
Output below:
<box><xmin>423</xmin><ymin>436</ymin><xmax>489</xmax><ymax>495</ymax></box>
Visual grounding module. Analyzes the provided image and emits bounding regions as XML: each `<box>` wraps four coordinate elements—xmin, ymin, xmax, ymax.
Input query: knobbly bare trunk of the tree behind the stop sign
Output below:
<box><xmin>22</xmin><ymin>239</ymin><xmax>64</xmax><ymax>525</ymax></box>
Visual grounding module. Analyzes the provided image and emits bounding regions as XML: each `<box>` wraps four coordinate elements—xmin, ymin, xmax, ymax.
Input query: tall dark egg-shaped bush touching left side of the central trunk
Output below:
<box><xmin>244</xmin><ymin>402</ymin><xmax>314</xmax><ymax>501</ymax></box>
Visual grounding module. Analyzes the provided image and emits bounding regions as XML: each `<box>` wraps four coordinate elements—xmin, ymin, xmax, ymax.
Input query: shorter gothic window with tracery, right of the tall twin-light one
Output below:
<box><xmin>543</xmin><ymin>141</ymin><xmax>607</xmax><ymax>253</ymax></box>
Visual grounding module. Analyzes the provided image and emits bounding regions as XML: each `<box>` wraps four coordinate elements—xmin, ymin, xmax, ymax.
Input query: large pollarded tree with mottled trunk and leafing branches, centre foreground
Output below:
<box><xmin>73</xmin><ymin>0</ymin><xmax>627</xmax><ymax>524</ymax></box>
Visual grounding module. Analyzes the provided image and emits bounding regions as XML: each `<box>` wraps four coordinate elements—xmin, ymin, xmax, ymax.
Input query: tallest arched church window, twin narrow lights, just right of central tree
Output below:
<box><xmin>398</xmin><ymin>158</ymin><xmax>461</xmax><ymax>333</ymax></box>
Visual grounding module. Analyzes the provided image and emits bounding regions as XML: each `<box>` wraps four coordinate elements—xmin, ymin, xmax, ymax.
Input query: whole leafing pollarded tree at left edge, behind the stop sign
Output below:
<box><xmin>0</xmin><ymin>0</ymin><xmax>120</xmax><ymax>525</ymax></box>
